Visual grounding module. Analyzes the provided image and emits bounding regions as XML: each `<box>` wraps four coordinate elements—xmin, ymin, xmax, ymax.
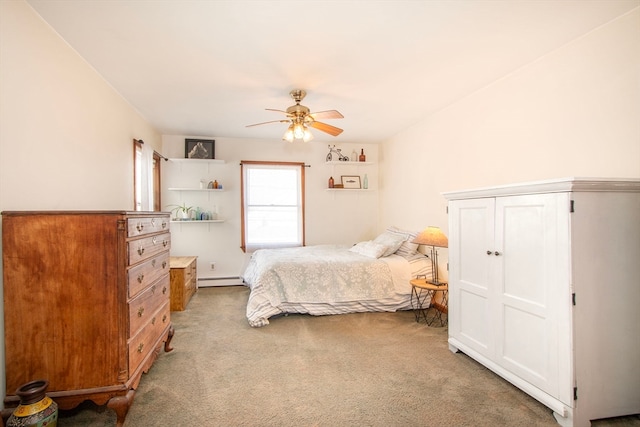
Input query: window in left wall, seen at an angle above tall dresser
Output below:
<box><xmin>133</xmin><ymin>139</ymin><xmax>161</xmax><ymax>211</ymax></box>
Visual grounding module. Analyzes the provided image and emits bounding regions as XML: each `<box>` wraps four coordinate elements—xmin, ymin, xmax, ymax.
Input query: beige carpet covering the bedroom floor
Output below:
<box><xmin>59</xmin><ymin>286</ymin><xmax>640</xmax><ymax>427</ymax></box>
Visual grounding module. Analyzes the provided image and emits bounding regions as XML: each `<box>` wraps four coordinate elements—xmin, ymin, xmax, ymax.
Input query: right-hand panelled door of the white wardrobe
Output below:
<box><xmin>492</xmin><ymin>193</ymin><xmax>570</xmax><ymax>398</ymax></box>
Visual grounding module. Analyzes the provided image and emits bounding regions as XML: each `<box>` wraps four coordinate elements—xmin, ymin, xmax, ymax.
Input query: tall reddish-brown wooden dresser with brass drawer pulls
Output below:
<box><xmin>2</xmin><ymin>211</ymin><xmax>173</xmax><ymax>426</ymax></box>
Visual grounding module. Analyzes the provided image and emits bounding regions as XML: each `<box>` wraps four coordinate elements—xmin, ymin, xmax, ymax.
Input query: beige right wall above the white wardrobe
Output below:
<box><xmin>380</xmin><ymin>9</ymin><xmax>640</xmax><ymax>246</ymax></box>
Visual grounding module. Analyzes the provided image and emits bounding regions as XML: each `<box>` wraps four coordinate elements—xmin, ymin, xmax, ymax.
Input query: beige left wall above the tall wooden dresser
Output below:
<box><xmin>0</xmin><ymin>1</ymin><xmax>161</xmax><ymax>210</ymax></box>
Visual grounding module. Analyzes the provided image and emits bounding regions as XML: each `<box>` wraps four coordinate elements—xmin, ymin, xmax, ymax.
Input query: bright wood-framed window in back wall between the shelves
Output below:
<box><xmin>241</xmin><ymin>160</ymin><xmax>304</xmax><ymax>252</ymax></box>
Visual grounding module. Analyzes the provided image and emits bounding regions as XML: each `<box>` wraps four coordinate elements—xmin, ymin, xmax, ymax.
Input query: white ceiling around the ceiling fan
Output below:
<box><xmin>28</xmin><ymin>0</ymin><xmax>640</xmax><ymax>143</ymax></box>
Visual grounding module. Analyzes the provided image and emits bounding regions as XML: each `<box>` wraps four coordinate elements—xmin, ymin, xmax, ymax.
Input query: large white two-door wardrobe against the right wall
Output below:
<box><xmin>444</xmin><ymin>178</ymin><xmax>640</xmax><ymax>426</ymax></box>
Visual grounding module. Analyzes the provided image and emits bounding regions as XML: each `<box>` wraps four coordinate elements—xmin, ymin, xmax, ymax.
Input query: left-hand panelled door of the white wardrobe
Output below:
<box><xmin>449</xmin><ymin>198</ymin><xmax>495</xmax><ymax>358</ymax></box>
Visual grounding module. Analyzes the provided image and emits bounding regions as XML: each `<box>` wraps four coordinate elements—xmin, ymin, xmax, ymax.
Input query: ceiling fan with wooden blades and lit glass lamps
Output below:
<box><xmin>247</xmin><ymin>89</ymin><xmax>344</xmax><ymax>142</ymax></box>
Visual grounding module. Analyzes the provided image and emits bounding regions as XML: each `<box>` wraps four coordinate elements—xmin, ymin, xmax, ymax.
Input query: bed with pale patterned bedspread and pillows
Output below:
<box><xmin>242</xmin><ymin>227</ymin><xmax>431</xmax><ymax>327</ymax></box>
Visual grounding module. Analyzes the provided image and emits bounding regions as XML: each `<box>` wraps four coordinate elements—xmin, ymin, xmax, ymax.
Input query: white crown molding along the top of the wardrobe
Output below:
<box><xmin>442</xmin><ymin>177</ymin><xmax>640</xmax><ymax>200</ymax></box>
